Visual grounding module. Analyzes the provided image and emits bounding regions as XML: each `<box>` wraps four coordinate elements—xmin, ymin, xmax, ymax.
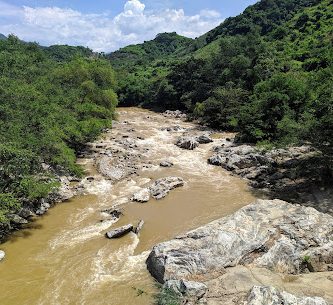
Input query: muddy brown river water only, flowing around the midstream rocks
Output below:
<box><xmin>0</xmin><ymin>108</ymin><xmax>254</xmax><ymax>305</ymax></box>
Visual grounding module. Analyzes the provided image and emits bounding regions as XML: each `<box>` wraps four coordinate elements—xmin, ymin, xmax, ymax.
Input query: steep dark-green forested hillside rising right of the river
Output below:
<box><xmin>111</xmin><ymin>0</ymin><xmax>333</xmax><ymax>162</ymax></box>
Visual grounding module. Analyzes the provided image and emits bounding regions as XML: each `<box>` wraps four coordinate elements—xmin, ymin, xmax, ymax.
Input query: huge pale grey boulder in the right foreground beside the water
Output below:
<box><xmin>147</xmin><ymin>200</ymin><xmax>333</xmax><ymax>283</ymax></box>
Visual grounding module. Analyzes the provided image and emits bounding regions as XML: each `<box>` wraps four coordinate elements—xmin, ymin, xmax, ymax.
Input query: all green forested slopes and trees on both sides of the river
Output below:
<box><xmin>0</xmin><ymin>0</ymin><xmax>333</xmax><ymax>227</ymax></box>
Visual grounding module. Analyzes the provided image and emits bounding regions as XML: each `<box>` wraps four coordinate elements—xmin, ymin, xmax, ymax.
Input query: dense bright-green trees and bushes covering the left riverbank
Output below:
<box><xmin>0</xmin><ymin>36</ymin><xmax>117</xmax><ymax>223</ymax></box>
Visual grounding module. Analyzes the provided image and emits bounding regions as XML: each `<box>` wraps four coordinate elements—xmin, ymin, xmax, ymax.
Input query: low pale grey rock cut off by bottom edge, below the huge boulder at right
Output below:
<box><xmin>245</xmin><ymin>286</ymin><xmax>328</xmax><ymax>305</ymax></box>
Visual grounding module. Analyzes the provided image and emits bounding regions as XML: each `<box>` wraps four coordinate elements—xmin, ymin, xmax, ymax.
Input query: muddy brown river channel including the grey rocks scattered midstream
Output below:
<box><xmin>0</xmin><ymin>109</ymin><xmax>254</xmax><ymax>305</ymax></box>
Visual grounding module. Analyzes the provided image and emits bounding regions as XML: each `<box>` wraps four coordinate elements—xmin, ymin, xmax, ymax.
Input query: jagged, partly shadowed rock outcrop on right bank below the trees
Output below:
<box><xmin>208</xmin><ymin>142</ymin><xmax>333</xmax><ymax>215</ymax></box>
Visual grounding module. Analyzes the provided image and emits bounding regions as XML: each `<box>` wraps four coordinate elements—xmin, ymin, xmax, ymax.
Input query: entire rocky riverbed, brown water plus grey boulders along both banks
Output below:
<box><xmin>0</xmin><ymin>109</ymin><xmax>333</xmax><ymax>305</ymax></box>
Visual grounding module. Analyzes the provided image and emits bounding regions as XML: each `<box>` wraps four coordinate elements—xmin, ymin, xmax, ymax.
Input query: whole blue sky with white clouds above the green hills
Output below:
<box><xmin>0</xmin><ymin>0</ymin><xmax>257</xmax><ymax>52</ymax></box>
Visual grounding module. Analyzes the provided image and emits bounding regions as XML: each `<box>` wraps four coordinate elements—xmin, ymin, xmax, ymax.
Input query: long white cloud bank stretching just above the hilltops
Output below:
<box><xmin>0</xmin><ymin>0</ymin><xmax>222</xmax><ymax>52</ymax></box>
